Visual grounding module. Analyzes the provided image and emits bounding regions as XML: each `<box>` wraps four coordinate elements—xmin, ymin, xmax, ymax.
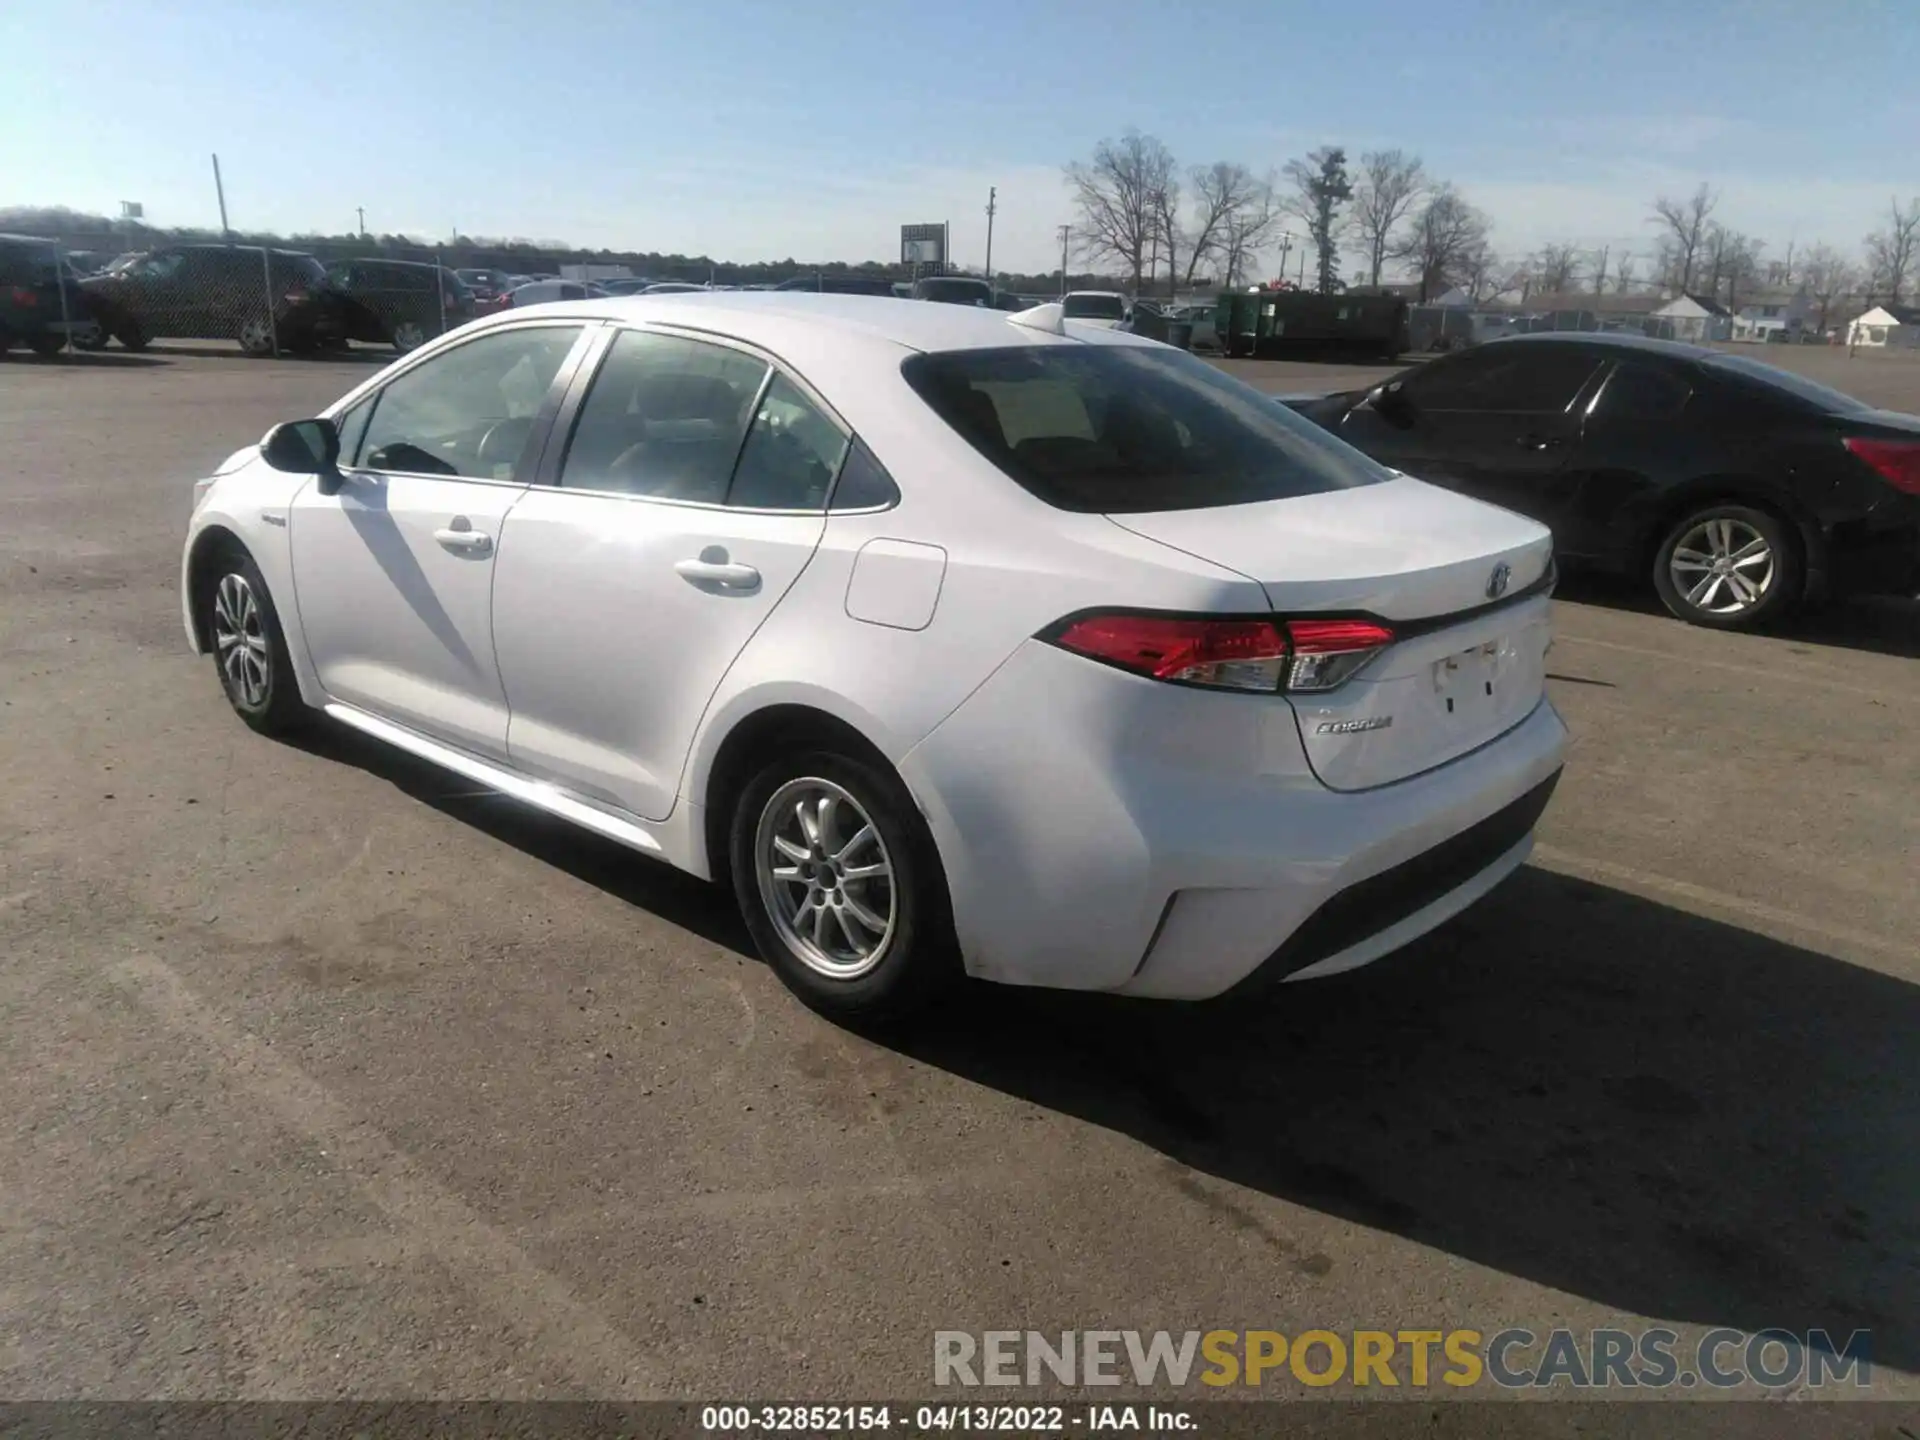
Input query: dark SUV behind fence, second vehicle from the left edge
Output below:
<box><xmin>81</xmin><ymin>246</ymin><xmax>346</xmax><ymax>355</ymax></box>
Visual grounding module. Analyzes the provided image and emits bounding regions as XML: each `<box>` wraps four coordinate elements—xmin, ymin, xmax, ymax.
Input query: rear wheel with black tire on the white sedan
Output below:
<box><xmin>730</xmin><ymin>751</ymin><xmax>960</xmax><ymax>1025</ymax></box>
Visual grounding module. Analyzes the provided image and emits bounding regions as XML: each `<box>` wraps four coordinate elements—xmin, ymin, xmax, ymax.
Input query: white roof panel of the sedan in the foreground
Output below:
<box><xmin>487</xmin><ymin>290</ymin><xmax>1152</xmax><ymax>353</ymax></box>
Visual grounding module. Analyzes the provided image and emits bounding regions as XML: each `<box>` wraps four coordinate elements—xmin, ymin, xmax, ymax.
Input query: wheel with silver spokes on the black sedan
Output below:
<box><xmin>1653</xmin><ymin>503</ymin><xmax>1805</xmax><ymax>630</ymax></box>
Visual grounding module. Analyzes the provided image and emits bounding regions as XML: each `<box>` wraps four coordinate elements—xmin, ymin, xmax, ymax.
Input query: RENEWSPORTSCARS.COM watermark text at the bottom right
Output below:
<box><xmin>933</xmin><ymin>1327</ymin><xmax>1872</xmax><ymax>1390</ymax></box>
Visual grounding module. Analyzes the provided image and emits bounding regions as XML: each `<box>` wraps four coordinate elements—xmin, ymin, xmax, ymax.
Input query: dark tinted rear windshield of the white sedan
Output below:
<box><xmin>900</xmin><ymin>346</ymin><xmax>1390</xmax><ymax>515</ymax></box>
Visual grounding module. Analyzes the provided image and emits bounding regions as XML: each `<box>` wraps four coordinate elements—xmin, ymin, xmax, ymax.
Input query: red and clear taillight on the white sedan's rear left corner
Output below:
<box><xmin>1043</xmin><ymin>614</ymin><xmax>1394</xmax><ymax>695</ymax></box>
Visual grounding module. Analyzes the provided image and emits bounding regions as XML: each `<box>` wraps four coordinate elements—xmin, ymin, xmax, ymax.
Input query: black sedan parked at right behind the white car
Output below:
<box><xmin>1286</xmin><ymin>334</ymin><xmax>1920</xmax><ymax>630</ymax></box>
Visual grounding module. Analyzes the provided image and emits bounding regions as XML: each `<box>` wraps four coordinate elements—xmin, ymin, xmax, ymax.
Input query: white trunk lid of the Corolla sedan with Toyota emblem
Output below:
<box><xmin>1108</xmin><ymin>478</ymin><xmax>1553</xmax><ymax>791</ymax></box>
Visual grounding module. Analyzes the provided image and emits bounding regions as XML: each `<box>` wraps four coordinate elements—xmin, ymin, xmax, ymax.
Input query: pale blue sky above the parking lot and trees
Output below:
<box><xmin>0</xmin><ymin>0</ymin><xmax>1920</xmax><ymax>269</ymax></box>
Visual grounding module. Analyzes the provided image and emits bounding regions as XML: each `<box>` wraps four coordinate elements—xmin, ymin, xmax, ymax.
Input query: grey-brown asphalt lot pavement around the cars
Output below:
<box><xmin>0</xmin><ymin>348</ymin><xmax>1920</xmax><ymax>1402</ymax></box>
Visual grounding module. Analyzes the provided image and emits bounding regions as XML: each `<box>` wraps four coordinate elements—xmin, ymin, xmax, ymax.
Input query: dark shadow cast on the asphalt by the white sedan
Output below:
<box><xmin>278</xmin><ymin>724</ymin><xmax>1920</xmax><ymax>1371</ymax></box>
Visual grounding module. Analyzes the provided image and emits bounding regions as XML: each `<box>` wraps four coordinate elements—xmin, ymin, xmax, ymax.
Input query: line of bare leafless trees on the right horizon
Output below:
<box><xmin>1064</xmin><ymin>131</ymin><xmax>1920</xmax><ymax>328</ymax></box>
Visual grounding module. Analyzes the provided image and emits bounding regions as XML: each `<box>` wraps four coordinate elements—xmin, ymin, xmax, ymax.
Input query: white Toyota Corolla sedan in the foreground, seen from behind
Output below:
<box><xmin>180</xmin><ymin>292</ymin><xmax>1567</xmax><ymax>1021</ymax></box>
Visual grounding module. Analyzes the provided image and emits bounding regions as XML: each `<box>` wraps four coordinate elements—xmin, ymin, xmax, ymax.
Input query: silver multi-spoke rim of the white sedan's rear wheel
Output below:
<box><xmin>753</xmin><ymin>776</ymin><xmax>900</xmax><ymax>979</ymax></box>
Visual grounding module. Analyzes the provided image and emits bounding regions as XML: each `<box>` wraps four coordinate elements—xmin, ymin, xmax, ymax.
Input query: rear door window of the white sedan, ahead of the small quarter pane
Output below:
<box><xmin>561</xmin><ymin>330</ymin><xmax>766</xmax><ymax>505</ymax></box>
